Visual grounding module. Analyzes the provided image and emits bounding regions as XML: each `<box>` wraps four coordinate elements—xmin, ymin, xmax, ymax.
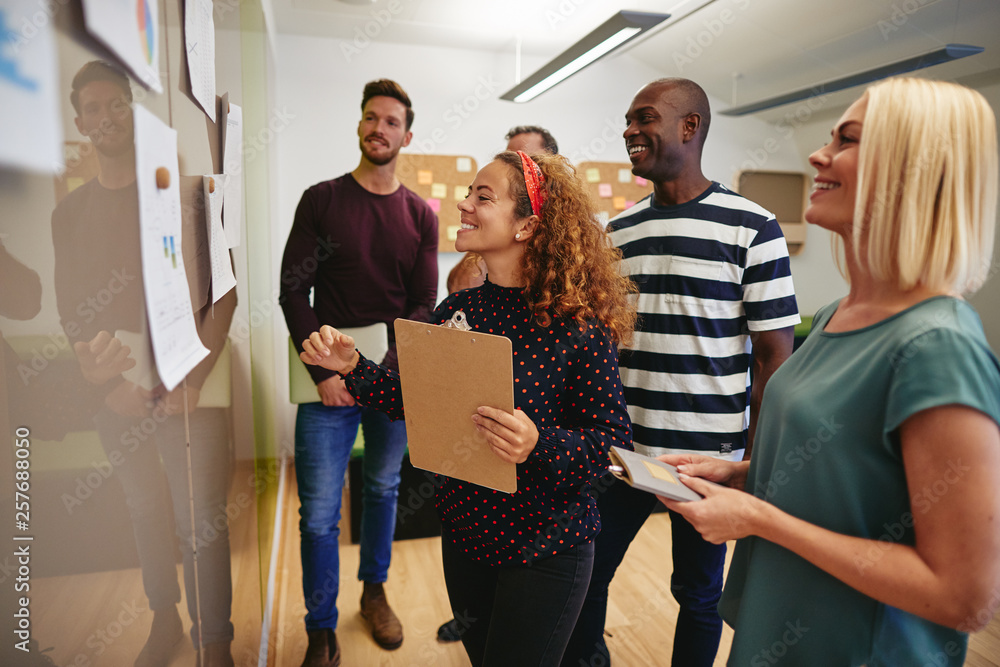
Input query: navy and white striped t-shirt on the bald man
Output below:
<box><xmin>608</xmin><ymin>183</ymin><xmax>799</xmax><ymax>460</ymax></box>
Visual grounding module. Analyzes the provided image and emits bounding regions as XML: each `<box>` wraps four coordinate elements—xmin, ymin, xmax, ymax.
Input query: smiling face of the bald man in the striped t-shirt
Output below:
<box><xmin>622</xmin><ymin>83</ymin><xmax>688</xmax><ymax>182</ymax></box>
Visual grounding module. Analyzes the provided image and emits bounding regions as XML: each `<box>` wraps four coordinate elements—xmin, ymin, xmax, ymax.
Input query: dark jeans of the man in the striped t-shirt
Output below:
<box><xmin>562</xmin><ymin>478</ymin><xmax>726</xmax><ymax>667</ymax></box>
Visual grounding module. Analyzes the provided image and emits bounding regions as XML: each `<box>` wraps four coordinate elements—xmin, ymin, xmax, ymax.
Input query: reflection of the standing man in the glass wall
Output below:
<box><xmin>52</xmin><ymin>61</ymin><xmax>235</xmax><ymax>667</ymax></box>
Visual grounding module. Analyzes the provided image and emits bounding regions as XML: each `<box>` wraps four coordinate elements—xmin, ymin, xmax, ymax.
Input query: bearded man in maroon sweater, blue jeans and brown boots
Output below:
<box><xmin>281</xmin><ymin>79</ymin><xmax>438</xmax><ymax>667</ymax></box>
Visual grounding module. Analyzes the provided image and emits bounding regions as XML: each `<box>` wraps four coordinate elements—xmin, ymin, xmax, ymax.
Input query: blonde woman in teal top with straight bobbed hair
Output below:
<box><xmin>665</xmin><ymin>79</ymin><xmax>1000</xmax><ymax>667</ymax></box>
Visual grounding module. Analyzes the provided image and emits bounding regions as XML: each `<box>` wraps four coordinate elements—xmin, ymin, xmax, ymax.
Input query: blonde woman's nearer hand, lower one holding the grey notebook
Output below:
<box><xmin>657</xmin><ymin>480</ymin><xmax>770</xmax><ymax>544</ymax></box>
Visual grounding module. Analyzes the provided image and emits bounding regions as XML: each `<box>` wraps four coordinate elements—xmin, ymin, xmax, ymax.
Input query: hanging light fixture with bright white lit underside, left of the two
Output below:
<box><xmin>500</xmin><ymin>10</ymin><xmax>670</xmax><ymax>102</ymax></box>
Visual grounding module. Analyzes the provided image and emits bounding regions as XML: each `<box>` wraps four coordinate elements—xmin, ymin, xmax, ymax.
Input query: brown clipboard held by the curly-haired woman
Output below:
<box><xmin>395</xmin><ymin>319</ymin><xmax>517</xmax><ymax>493</ymax></box>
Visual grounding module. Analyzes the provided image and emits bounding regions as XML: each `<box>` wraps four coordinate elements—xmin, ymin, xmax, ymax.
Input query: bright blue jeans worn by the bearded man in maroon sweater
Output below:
<box><xmin>295</xmin><ymin>403</ymin><xmax>406</xmax><ymax>630</ymax></box>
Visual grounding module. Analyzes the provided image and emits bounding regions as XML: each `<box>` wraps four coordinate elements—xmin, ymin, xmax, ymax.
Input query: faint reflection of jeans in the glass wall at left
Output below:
<box><xmin>94</xmin><ymin>408</ymin><xmax>233</xmax><ymax>646</ymax></box>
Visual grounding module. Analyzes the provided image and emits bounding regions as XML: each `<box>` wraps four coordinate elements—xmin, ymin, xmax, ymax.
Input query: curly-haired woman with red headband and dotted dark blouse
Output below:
<box><xmin>302</xmin><ymin>151</ymin><xmax>635</xmax><ymax>667</ymax></box>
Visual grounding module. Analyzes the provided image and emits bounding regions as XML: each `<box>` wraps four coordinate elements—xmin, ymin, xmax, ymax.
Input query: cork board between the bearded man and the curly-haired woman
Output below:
<box><xmin>396</xmin><ymin>153</ymin><xmax>479</xmax><ymax>252</ymax></box>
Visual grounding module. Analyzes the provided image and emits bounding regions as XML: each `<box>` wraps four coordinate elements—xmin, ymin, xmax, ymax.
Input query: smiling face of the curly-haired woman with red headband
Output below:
<box><xmin>455</xmin><ymin>160</ymin><xmax>519</xmax><ymax>257</ymax></box>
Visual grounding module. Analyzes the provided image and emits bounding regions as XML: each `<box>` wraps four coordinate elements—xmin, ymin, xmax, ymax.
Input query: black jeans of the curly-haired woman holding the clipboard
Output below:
<box><xmin>441</xmin><ymin>536</ymin><xmax>594</xmax><ymax>667</ymax></box>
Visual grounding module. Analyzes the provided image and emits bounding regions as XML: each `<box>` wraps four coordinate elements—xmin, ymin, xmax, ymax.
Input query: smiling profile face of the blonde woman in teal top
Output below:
<box><xmin>805</xmin><ymin>97</ymin><xmax>868</xmax><ymax>235</ymax></box>
